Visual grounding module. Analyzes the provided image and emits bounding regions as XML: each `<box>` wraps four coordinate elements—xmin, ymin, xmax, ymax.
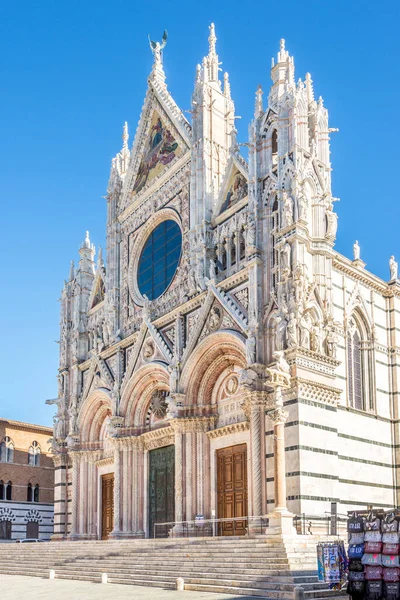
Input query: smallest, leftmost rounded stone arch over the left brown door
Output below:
<box><xmin>78</xmin><ymin>388</ymin><xmax>112</xmax><ymax>442</ymax></box>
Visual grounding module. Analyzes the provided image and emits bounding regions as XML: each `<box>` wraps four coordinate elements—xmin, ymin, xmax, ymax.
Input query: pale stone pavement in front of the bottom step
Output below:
<box><xmin>0</xmin><ymin>575</ymin><xmax>254</xmax><ymax>600</ymax></box>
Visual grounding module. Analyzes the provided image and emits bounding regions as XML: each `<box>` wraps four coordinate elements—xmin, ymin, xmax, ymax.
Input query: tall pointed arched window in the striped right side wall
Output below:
<box><xmin>347</xmin><ymin>318</ymin><xmax>374</xmax><ymax>410</ymax></box>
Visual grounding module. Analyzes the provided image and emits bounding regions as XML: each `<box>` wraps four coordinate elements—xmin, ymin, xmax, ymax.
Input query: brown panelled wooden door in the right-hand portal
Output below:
<box><xmin>217</xmin><ymin>444</ymin><xmax>247</xmax><ymax>535</ymax></box>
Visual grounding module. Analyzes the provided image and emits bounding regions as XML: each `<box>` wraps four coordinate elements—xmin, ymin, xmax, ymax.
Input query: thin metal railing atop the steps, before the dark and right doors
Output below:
<box><xmin>153</xmin><ymin>515</ymin><xmax>269</xmax><ymax>538</ymax></box>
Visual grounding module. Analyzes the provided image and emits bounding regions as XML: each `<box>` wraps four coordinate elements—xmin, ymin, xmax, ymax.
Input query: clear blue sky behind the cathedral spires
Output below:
<box><xmin>0</xmin><ymin>0</ymin><xmax>400</xmax><ymax>424</ymax></box>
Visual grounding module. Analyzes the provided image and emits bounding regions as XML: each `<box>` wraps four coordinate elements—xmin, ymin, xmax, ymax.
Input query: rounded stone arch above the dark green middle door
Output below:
<box><xmin>121</xmin><ymin>361</ymin><xmax>169</xmax><ymax>427</ymax></box>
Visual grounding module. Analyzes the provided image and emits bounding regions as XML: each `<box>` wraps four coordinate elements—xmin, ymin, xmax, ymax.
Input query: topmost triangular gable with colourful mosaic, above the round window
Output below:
<box><xmin>121</xmin><ymin>83</ymin><xmax>191</xmax><ymax>210</ymax></box>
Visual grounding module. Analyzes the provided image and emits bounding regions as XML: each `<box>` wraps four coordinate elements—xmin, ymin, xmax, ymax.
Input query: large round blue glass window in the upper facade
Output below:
<box><xmin>138</xmin><ymin>219</ymin><xmax>182</xmax><ymax>300</ymax></box>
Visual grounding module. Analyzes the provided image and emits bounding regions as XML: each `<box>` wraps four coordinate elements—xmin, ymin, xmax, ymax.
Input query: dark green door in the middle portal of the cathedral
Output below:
<box><xmin>149</xmin><ymin>446</ymin><xmax>175</xmax><ymax>537</ymax></box>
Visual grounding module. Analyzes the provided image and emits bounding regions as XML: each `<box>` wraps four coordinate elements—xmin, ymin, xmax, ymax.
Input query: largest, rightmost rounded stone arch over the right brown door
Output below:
<box><xmin>180</xmin><ymin>331</ymin><xmax>246</xmax><ymax>405</ymax></box>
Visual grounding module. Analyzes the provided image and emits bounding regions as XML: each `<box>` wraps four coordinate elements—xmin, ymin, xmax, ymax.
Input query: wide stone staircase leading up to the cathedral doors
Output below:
<box><xmin>0</xmin><ymin>536</ymin><xmax>346</xmax><ymax>600</ymax></box>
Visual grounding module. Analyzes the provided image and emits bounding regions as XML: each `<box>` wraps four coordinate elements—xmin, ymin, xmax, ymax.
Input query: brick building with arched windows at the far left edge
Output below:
<box><xmin>0</xmin><ymin>419</ymin><xmax>54</xmax><ymax>541</ymax></box>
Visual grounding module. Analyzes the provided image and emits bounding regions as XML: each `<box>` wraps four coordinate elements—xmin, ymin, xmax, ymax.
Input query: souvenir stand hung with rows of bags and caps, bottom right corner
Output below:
<box><xmin>347</xmin><ymin>510</ymin><xmax>400</xmax><ymax>600</ymax></box>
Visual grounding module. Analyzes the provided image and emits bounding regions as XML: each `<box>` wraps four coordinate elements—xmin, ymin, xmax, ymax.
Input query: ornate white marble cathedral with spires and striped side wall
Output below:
<box><xmin>53</xmin><ymin>25</ymin><xmax>400</xmax><ymax>539</ymax></box>
